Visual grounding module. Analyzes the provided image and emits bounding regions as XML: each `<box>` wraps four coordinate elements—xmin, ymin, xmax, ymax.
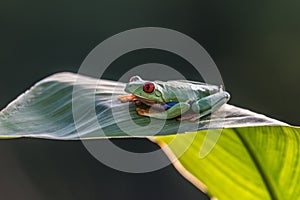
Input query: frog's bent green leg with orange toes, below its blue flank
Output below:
<box><xmin>136</xmin><ymin>102</ymin><xmax>190</xmax><ymax>119</ymax></box>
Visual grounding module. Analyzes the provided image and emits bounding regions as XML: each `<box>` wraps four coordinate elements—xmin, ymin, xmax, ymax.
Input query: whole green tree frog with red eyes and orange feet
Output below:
<box><xmin>118</xmin><ymin>76</ymin><xmax>230</xmax><ymax>121</ymax></box>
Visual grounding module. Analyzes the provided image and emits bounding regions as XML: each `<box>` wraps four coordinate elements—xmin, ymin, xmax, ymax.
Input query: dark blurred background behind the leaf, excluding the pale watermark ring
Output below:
<box><xmin>0</xmin><ymin>0</ymin><xmax>300</xmax><ymax>200</ymax></box>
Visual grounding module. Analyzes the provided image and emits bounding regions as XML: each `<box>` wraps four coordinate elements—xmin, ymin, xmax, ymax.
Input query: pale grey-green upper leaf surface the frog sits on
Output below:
<box><xmin>0</xmin><ymin>73</ymin><xmax>286</xmax><ymax>140</ymax></box>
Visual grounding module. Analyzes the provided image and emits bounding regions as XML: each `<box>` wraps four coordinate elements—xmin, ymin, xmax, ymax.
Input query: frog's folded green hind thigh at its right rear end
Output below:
<box><xmin>192</xmin><ymin>91</ymin><xmax>230</xmax><ymax>116</ymax></box>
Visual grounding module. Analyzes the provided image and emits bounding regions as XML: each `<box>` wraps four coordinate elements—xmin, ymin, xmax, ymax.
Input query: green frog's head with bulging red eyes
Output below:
<box><xmin>125</xmin><ymin>76</ymin><xmax>164</xmax><ymax>103</ymax></box>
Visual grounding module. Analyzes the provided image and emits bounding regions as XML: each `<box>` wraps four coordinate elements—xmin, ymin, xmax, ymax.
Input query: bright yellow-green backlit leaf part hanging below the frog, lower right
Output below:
<box><xmin>155</xmin><ymin>126</ymin><xmax>300</xmax><ymax>200</ymax></box>
